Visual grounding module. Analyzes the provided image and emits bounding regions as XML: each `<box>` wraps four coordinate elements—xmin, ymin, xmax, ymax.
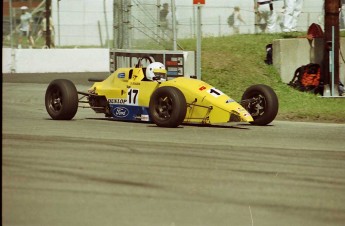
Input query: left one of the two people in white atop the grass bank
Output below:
<box><xmin>256</xmin><ymin>0</ymin><xmax>277</xmax><ymax>33</ymax></box>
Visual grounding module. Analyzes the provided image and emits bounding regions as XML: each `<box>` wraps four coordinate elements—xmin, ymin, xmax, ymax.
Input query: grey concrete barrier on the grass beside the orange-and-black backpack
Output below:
<box><xmin>272</xmin><ymin>38</ymin><xmax>345</xmax><ymax>83</ymax></box>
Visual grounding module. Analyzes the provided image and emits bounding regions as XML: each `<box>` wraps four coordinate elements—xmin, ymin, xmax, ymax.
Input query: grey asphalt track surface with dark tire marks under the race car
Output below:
<box><xmin>2</xmin><ymin>74</ymin><xmax>345</xmax><ymax>226</ymax></box>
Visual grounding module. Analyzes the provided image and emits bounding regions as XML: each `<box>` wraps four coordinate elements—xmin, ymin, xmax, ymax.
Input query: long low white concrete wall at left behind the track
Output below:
<box><xmin>2</xmin><ymin>48</ymin><xmax>109</xmax><ymax>73</ymax></box>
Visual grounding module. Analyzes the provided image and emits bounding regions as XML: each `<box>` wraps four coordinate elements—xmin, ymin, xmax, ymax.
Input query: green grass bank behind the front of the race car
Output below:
<box><xmin>180</xmin><ymin>32</ymin><xmax>345</xmax><ymax>123</ymax></box>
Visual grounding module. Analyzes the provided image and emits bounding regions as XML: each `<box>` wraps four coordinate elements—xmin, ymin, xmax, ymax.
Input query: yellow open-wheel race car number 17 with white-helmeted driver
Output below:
<box><xmin>45</xmin><ymin>56</ymin><xmax>278</xmax><ymax>128</ymax></box>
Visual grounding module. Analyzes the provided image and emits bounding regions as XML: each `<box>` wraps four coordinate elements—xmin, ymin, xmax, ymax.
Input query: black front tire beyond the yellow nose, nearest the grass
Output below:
<box><xmin>241</xmin><ymin>84</ymin><xmax>279</xmax><ymax>126</ymax></box>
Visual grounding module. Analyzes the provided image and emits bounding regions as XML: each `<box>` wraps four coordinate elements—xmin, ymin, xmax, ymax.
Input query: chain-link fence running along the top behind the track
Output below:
<box><xmin>3</xmin><ymin>0</ymin><xmax>332</xmax><ymax>49</ymax></box>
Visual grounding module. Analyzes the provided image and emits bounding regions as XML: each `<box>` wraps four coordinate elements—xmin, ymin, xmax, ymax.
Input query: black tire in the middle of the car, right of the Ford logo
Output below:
<box><xmin>149</xmin><ymin>86</ymin><xmax>187</xmax><ymax>128</ymax></box>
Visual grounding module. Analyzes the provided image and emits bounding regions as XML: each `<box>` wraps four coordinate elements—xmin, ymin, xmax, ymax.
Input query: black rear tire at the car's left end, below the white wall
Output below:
<box><xmin>45</xmin><ymin>79</ymin><xmax>78</xmax><ymax>120</ymax></box>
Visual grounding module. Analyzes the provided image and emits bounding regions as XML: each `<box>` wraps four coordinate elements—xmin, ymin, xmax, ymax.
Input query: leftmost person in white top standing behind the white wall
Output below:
<box><xmin>18</xmin><ymin>6</ymin><xmax>35</xmax><ymax>48</ymax></box>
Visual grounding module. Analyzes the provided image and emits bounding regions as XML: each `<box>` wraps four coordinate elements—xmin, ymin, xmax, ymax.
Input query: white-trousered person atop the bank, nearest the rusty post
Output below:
<box><xmin>283</xmin><ymin>0</ymin><xmax>303</xmax><ymax>32</ymax></box>
